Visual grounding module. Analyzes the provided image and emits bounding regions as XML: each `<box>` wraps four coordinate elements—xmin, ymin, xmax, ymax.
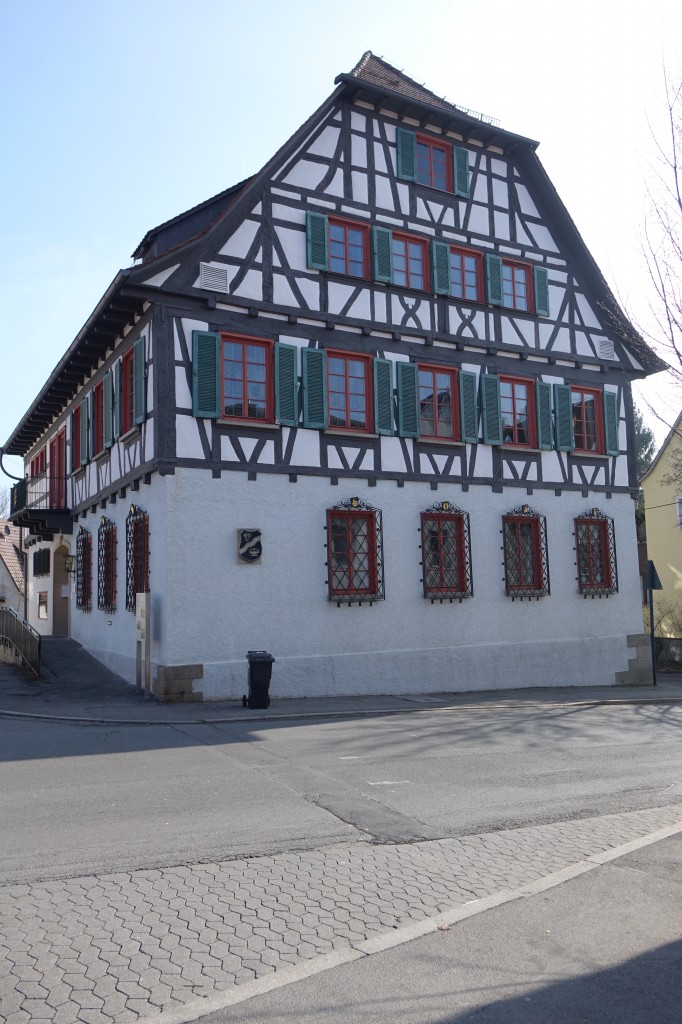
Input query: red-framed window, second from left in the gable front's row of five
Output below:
<box><xmin>327</xmin><ymin>350</ymin><xmax>374</xmax><ymax>433</ymax></box>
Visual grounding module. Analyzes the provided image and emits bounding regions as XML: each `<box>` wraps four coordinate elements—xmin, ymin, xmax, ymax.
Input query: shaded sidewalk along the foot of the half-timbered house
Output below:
<box><xmin>0</xmin><ymin>637</ymin><xmax>682</xmax><ymax>725</ymax></box>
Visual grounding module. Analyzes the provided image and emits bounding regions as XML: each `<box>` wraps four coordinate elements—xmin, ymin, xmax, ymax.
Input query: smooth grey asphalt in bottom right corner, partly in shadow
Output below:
<box><xmin>201</xmin><ymin>835</ymin><xmax>682</xmax><ymax>1024</ymax></box>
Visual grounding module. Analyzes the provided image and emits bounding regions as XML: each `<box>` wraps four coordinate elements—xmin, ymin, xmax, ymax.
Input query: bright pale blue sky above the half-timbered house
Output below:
<box><xmin>0</xmin><ymin>0</ymin><xmax>682</xmax><ymax>487</ymax></box>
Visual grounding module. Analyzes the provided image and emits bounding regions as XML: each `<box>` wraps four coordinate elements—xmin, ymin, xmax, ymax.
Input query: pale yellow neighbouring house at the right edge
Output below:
<box><xmin>640</xmin><ymin>413</ymin><xmax>682</xmax><ymax>638</ymax></box>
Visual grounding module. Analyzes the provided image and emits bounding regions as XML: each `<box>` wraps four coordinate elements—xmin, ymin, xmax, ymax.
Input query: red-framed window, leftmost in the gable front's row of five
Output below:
<box><xmin>220</xmin><ymin>334</ymin><xmax>274</xmax><ymax>423</ymax></box>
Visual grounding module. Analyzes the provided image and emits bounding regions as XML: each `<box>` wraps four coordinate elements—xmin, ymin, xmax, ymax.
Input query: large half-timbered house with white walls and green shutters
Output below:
<box><xmin>5</xmin><ymin>53</ymin><xmax>664</xmax><ymax>699</ymax></box>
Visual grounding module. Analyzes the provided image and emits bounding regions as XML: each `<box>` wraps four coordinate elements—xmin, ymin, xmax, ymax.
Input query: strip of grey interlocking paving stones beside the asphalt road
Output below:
<box><xmin>0</xmin><ymin>806</ymin><xmax>682</xmax><ymax>1024</ymax></box>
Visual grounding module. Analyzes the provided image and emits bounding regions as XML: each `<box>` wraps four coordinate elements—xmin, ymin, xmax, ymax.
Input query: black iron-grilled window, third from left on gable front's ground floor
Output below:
<box><xmin>500</xmin><ymin>505</ymin><xmax>550</xmax><ymax>601</ymax></box>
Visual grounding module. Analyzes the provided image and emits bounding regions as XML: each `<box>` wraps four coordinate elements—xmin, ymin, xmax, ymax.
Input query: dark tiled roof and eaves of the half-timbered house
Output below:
<box><xmin>4</xmin><ymin>50</ymin><xmax>667</xmax><ymax>456</ymax></box>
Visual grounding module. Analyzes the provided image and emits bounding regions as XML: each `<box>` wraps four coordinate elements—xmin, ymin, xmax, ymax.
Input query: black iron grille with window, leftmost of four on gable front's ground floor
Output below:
<box><xmin>325</xmin><ymin>498</ymin><xmax>384</xmax><ymax>608</ymax></box>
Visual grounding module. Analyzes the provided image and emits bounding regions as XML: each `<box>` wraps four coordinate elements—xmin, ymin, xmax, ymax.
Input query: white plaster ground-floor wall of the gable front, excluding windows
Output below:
<box><xmin>151</xmin><ymin>470</ymin><xmax>642</xmax><ymax>699</ymax></box>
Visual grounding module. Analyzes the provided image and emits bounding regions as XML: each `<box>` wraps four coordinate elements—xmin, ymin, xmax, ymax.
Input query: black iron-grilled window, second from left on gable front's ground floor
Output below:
<box><xmin>419</xmin><ymin>501</ymin><xmax>473</xmax><ymax>604</ymax></box>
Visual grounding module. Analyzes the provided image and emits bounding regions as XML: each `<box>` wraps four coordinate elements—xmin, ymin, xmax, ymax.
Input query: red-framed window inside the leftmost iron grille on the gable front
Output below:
<box><xmin>327</xmin><ymin>509</ymin><xmax>379</xmax><ymax>598</ymax></box>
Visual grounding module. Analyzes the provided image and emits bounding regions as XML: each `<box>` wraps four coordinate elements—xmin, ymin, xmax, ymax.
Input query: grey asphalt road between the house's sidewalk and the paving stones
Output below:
<box><xmin>0</xmin><ymin>705</ymin><xmax>682</xmax><ymax>884</ymax></box>
